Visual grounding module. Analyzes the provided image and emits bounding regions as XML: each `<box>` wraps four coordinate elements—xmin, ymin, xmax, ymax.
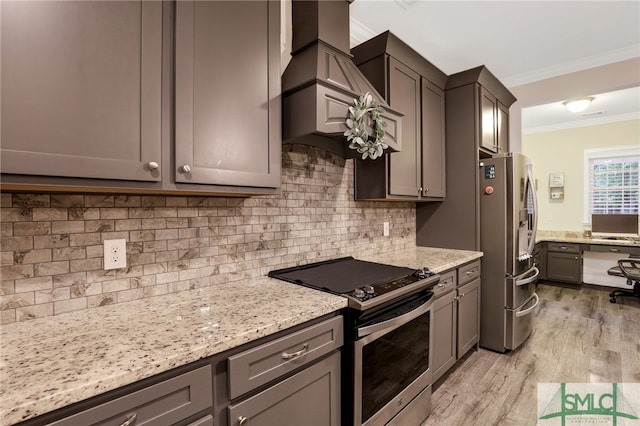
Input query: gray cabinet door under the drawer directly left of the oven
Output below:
<box><xmin>229</xmin><ymin>353</ymin><xmax>340</xmax><ymax>426</ymax></box>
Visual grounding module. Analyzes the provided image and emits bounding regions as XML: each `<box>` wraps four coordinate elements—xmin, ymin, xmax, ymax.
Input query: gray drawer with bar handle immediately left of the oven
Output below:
<box><xmin>227</xmin><ymin>316</ymin><xmax>344</xmax><ymax>399</ymax></box>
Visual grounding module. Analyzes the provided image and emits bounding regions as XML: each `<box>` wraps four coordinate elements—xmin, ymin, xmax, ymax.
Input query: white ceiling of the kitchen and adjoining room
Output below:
<box><xmin>350</xmin><ymin>0</ymin><xmax>640</xmax><ymax>134</ymax></box>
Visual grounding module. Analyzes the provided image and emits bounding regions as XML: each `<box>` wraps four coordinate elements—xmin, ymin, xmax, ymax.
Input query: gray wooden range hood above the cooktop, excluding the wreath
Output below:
<box><xmin>282</xmin><ymin>0</ymin><xmax>403</xmax><ymax>158</ymax></box>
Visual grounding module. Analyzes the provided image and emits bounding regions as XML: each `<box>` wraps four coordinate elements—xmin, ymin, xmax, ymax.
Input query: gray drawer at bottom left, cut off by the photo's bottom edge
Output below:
<box><xmin>51</xmin><ymin>365</ymin><xmax>213</xmax><ymax>426</ymax></box>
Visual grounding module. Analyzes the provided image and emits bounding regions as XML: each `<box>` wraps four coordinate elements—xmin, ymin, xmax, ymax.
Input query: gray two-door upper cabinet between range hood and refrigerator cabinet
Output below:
<box><xmin>351</xmin><ymin>31</ymin><xmax>447</xmax><ymax>201</ymax></box>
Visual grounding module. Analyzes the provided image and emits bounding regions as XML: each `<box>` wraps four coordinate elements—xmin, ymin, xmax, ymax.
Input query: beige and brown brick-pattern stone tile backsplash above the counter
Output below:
<box><xmin>0</xmin><ymin>145</ymin><xmax>415</xmax><ymax>324</ymax></box>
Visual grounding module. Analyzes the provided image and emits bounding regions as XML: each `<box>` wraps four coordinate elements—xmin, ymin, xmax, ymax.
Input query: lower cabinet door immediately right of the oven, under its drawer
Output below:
<box><xmin>431</xmin><ymin>291</ymin><xmax>458</xmax><ymax>382</ymax></box>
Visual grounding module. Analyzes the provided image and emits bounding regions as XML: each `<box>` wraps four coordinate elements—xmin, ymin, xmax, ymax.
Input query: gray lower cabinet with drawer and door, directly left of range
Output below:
<box><xmin>216</xmin><ymin>316</ymin><xmax>344</xmax><ymax>426</ymax></box>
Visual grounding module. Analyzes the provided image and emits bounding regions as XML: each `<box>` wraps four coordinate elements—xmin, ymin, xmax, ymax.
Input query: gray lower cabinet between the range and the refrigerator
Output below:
<box><xmin>431</xmin><ymin>261</ymin><xmax>480</xmax><ymax>381</ymax></box>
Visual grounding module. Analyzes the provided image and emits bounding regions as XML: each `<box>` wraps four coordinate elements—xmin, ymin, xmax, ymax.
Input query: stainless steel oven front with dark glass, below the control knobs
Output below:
<box><xmin>354</xmin><ymin>291</ymin><xmax>433</xmax><ymax>426</ymax></box>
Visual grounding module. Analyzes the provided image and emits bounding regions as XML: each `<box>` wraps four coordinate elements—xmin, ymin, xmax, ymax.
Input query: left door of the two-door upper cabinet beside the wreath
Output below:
<box><xmin>387</xmin><ymin>58</ymin><xmax>420</xmax><ymax>198</ymax></box>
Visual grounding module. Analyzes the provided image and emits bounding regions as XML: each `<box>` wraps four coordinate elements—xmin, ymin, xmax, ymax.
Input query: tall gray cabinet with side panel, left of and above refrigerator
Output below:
<box><xmin>416</xmin><ymin>66</ymin><xmax>516</xmax><ymax>250</ymax></box>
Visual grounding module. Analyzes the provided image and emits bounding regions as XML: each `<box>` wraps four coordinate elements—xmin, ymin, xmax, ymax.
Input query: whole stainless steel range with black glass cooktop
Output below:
<box><xmin>269</xmin><ymin>257</ymin><xmax>440</xmax><ymax>426</ymax></box>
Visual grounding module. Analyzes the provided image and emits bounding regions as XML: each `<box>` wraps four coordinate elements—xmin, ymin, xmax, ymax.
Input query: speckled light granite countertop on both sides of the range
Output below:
<box><xmin>0</xmin><ymin>247</ymin><xmax>482</xmax><ymax>425</ymax></box>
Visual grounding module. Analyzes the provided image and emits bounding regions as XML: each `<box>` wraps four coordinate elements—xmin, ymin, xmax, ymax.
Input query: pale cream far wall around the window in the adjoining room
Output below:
<box><xmin>522</xmin><ymin>120</ymin><xmax>640</xmax><ymax>232</ymax></box>
